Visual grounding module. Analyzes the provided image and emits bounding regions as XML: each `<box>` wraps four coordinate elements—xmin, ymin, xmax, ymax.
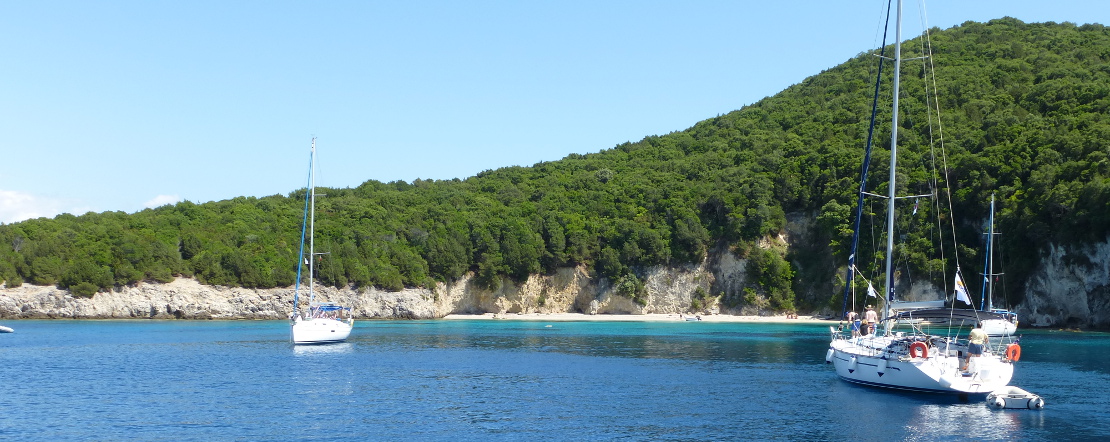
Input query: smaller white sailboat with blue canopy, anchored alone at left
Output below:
<box><xmin>290</xmin><ymin>138</ymin><xmax>354</xmax><ymax>344</ymax></box>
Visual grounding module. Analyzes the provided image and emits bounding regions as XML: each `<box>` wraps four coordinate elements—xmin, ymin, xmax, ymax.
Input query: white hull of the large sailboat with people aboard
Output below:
<box><xmin>826</xmin><ymin>336</ymin><xmax>1013</xmax><ymax>394</ymax></box>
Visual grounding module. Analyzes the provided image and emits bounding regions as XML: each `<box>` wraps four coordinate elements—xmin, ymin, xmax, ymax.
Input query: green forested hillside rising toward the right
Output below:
<box><xmin>0</xmin><ymin>19</ymin><xmax>1110</xmax><ymax>309</ymax></box>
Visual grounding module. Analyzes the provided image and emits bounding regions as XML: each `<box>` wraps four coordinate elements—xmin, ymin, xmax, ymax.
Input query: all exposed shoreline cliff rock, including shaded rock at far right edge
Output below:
<box><xmin>0</xmin><ymin>229</ymin><xmax>1110</xmax><ymax>329</ymax></box>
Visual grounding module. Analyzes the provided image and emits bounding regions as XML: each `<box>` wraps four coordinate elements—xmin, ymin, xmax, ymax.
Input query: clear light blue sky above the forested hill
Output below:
<box><xmin>0</xmin><ymin>0</ymin><xmax>1110</xmax><ymax>223</ymax></box>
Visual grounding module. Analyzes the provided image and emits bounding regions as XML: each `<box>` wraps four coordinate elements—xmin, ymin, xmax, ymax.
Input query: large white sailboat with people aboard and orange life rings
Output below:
<box><xmin>825</xmin><ymin>0</ymin><xmax>1020</xmax><ymax>395</ymax></box>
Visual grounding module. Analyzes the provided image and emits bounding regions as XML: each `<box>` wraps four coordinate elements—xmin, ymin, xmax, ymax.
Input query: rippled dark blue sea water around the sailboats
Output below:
<box><xmin>0</xmin><ymin>321</ymin><xmax>1110</xmax><ymax>441</ymax></box>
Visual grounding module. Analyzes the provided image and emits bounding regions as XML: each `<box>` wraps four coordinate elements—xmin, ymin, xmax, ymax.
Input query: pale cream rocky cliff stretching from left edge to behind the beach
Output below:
<box><xmin>0</xmin><ymin>253</ymin><xmax>743</xmax><ymax>320</ymax></box>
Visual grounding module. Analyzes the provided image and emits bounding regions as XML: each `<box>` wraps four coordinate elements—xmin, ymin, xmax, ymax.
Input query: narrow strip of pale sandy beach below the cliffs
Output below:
<box><xmin>443</xmin><ymin>313</ymin><xmax>836</xmax><ymax>324</ymax></box>
